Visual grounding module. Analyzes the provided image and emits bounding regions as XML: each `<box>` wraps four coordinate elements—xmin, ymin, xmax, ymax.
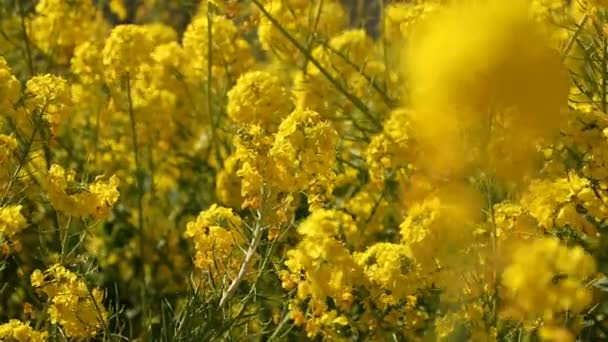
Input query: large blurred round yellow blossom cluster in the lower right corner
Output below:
<box><xmin>502</xmin><ymin>238</ymin><xmax>596</xmax><ymax>322</ymax></box>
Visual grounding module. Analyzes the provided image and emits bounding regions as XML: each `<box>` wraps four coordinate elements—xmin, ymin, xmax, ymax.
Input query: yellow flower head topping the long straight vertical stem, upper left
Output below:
<box><xmin>101</xmin><ymin>25</ymin><xmax>153</xmax><ymax>82</ymax></box>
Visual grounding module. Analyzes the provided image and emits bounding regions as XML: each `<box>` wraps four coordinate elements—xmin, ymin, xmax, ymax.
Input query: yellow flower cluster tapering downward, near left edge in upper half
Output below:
<box><xmin>25</xmin><ymin>74</ymin><xmax>72</xmax><ymax>134</ymax></box>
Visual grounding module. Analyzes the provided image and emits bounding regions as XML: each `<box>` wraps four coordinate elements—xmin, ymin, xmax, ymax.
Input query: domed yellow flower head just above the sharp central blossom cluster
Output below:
<box><xmin>226</xmin><ymin>71</ymin><xmax>291</xmax><ymax>131</ymax></box>
